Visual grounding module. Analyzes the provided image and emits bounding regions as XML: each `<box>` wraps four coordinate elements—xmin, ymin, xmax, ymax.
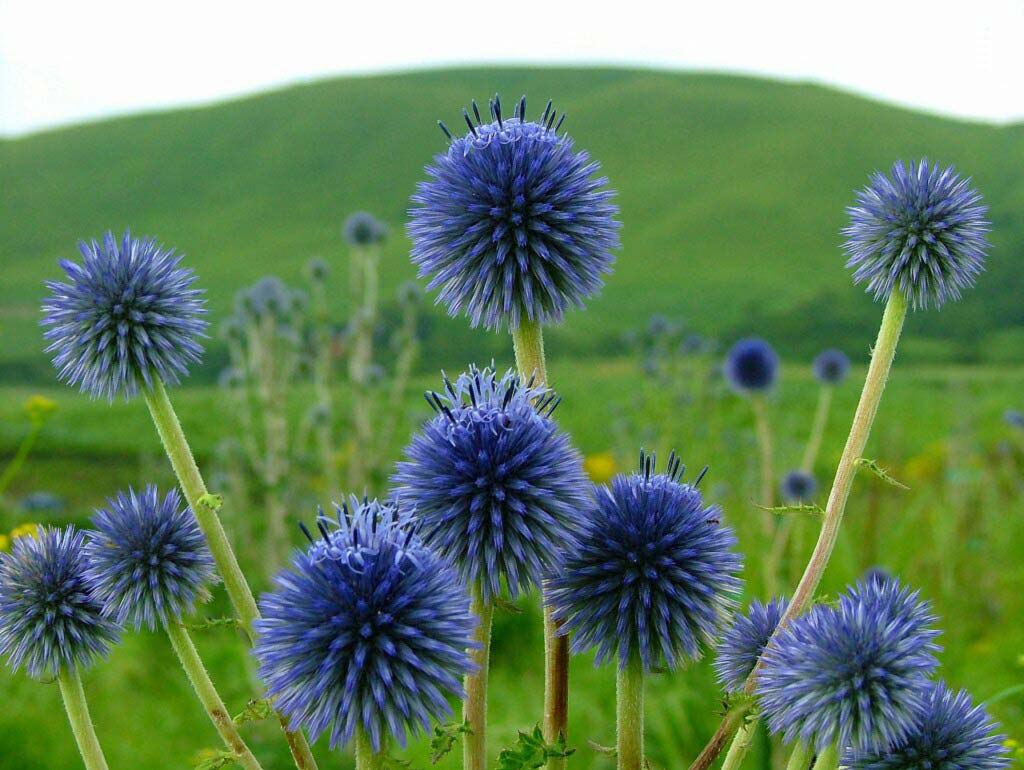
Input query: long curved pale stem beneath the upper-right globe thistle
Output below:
<box><xmin>690</xmin><ymin>290</ymin><xmax>906</xmax><ymax>770</ymax></box>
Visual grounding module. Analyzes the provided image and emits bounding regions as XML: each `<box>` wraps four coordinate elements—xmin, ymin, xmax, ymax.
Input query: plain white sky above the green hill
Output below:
<box><xmin>0</xmin><ymin>0</ymin><xmax>1024</xmax><ymax>135</ymax></box>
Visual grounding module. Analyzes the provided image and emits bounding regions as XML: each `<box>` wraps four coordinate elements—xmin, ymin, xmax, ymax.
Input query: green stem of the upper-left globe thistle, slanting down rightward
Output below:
<box><xmin>144</xmin><ymin>380</ymin><xmax>316</xmax><ymax>770</ymax></box>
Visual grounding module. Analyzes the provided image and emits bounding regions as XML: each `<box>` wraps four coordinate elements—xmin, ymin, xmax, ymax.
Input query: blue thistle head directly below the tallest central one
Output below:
<box><xmin>393</xmin><ymin>367</ymin><xmax>590</xmax><ymax>601</ymax></box>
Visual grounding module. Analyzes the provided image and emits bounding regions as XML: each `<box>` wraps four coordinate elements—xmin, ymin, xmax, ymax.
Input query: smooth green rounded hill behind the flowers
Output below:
<box><xmin>0</xmin><ymin>69</ymin><xmax>1024</xmax><ymax>382</ymax></box>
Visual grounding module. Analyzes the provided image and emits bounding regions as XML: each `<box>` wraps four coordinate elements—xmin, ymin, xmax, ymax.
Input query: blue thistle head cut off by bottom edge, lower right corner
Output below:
<box><xmin>842</xmin><ymin>682</ymin><xmax>1010</xmax><ymax>770</ymax></box>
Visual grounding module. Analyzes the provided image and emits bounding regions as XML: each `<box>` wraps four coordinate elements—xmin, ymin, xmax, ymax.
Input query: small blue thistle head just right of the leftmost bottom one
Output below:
<box><xmin>86</xmin><ymin>484</ymin><xmax>215</xmax><ymax>629</ymax></box>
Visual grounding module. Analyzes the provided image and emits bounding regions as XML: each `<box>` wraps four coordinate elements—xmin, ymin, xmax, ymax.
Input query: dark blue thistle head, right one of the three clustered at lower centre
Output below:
<box><xmin>547</xmin><ymin>453</ymin><xmax>740</xmax><ymax>671</ymax></box>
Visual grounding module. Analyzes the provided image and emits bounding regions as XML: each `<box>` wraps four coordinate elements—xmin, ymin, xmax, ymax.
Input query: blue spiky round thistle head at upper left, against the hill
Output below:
<box><xmin>42</xmin><ymin>230</ymin><xmax>207</xmax><ymax>399</ymax></box>
